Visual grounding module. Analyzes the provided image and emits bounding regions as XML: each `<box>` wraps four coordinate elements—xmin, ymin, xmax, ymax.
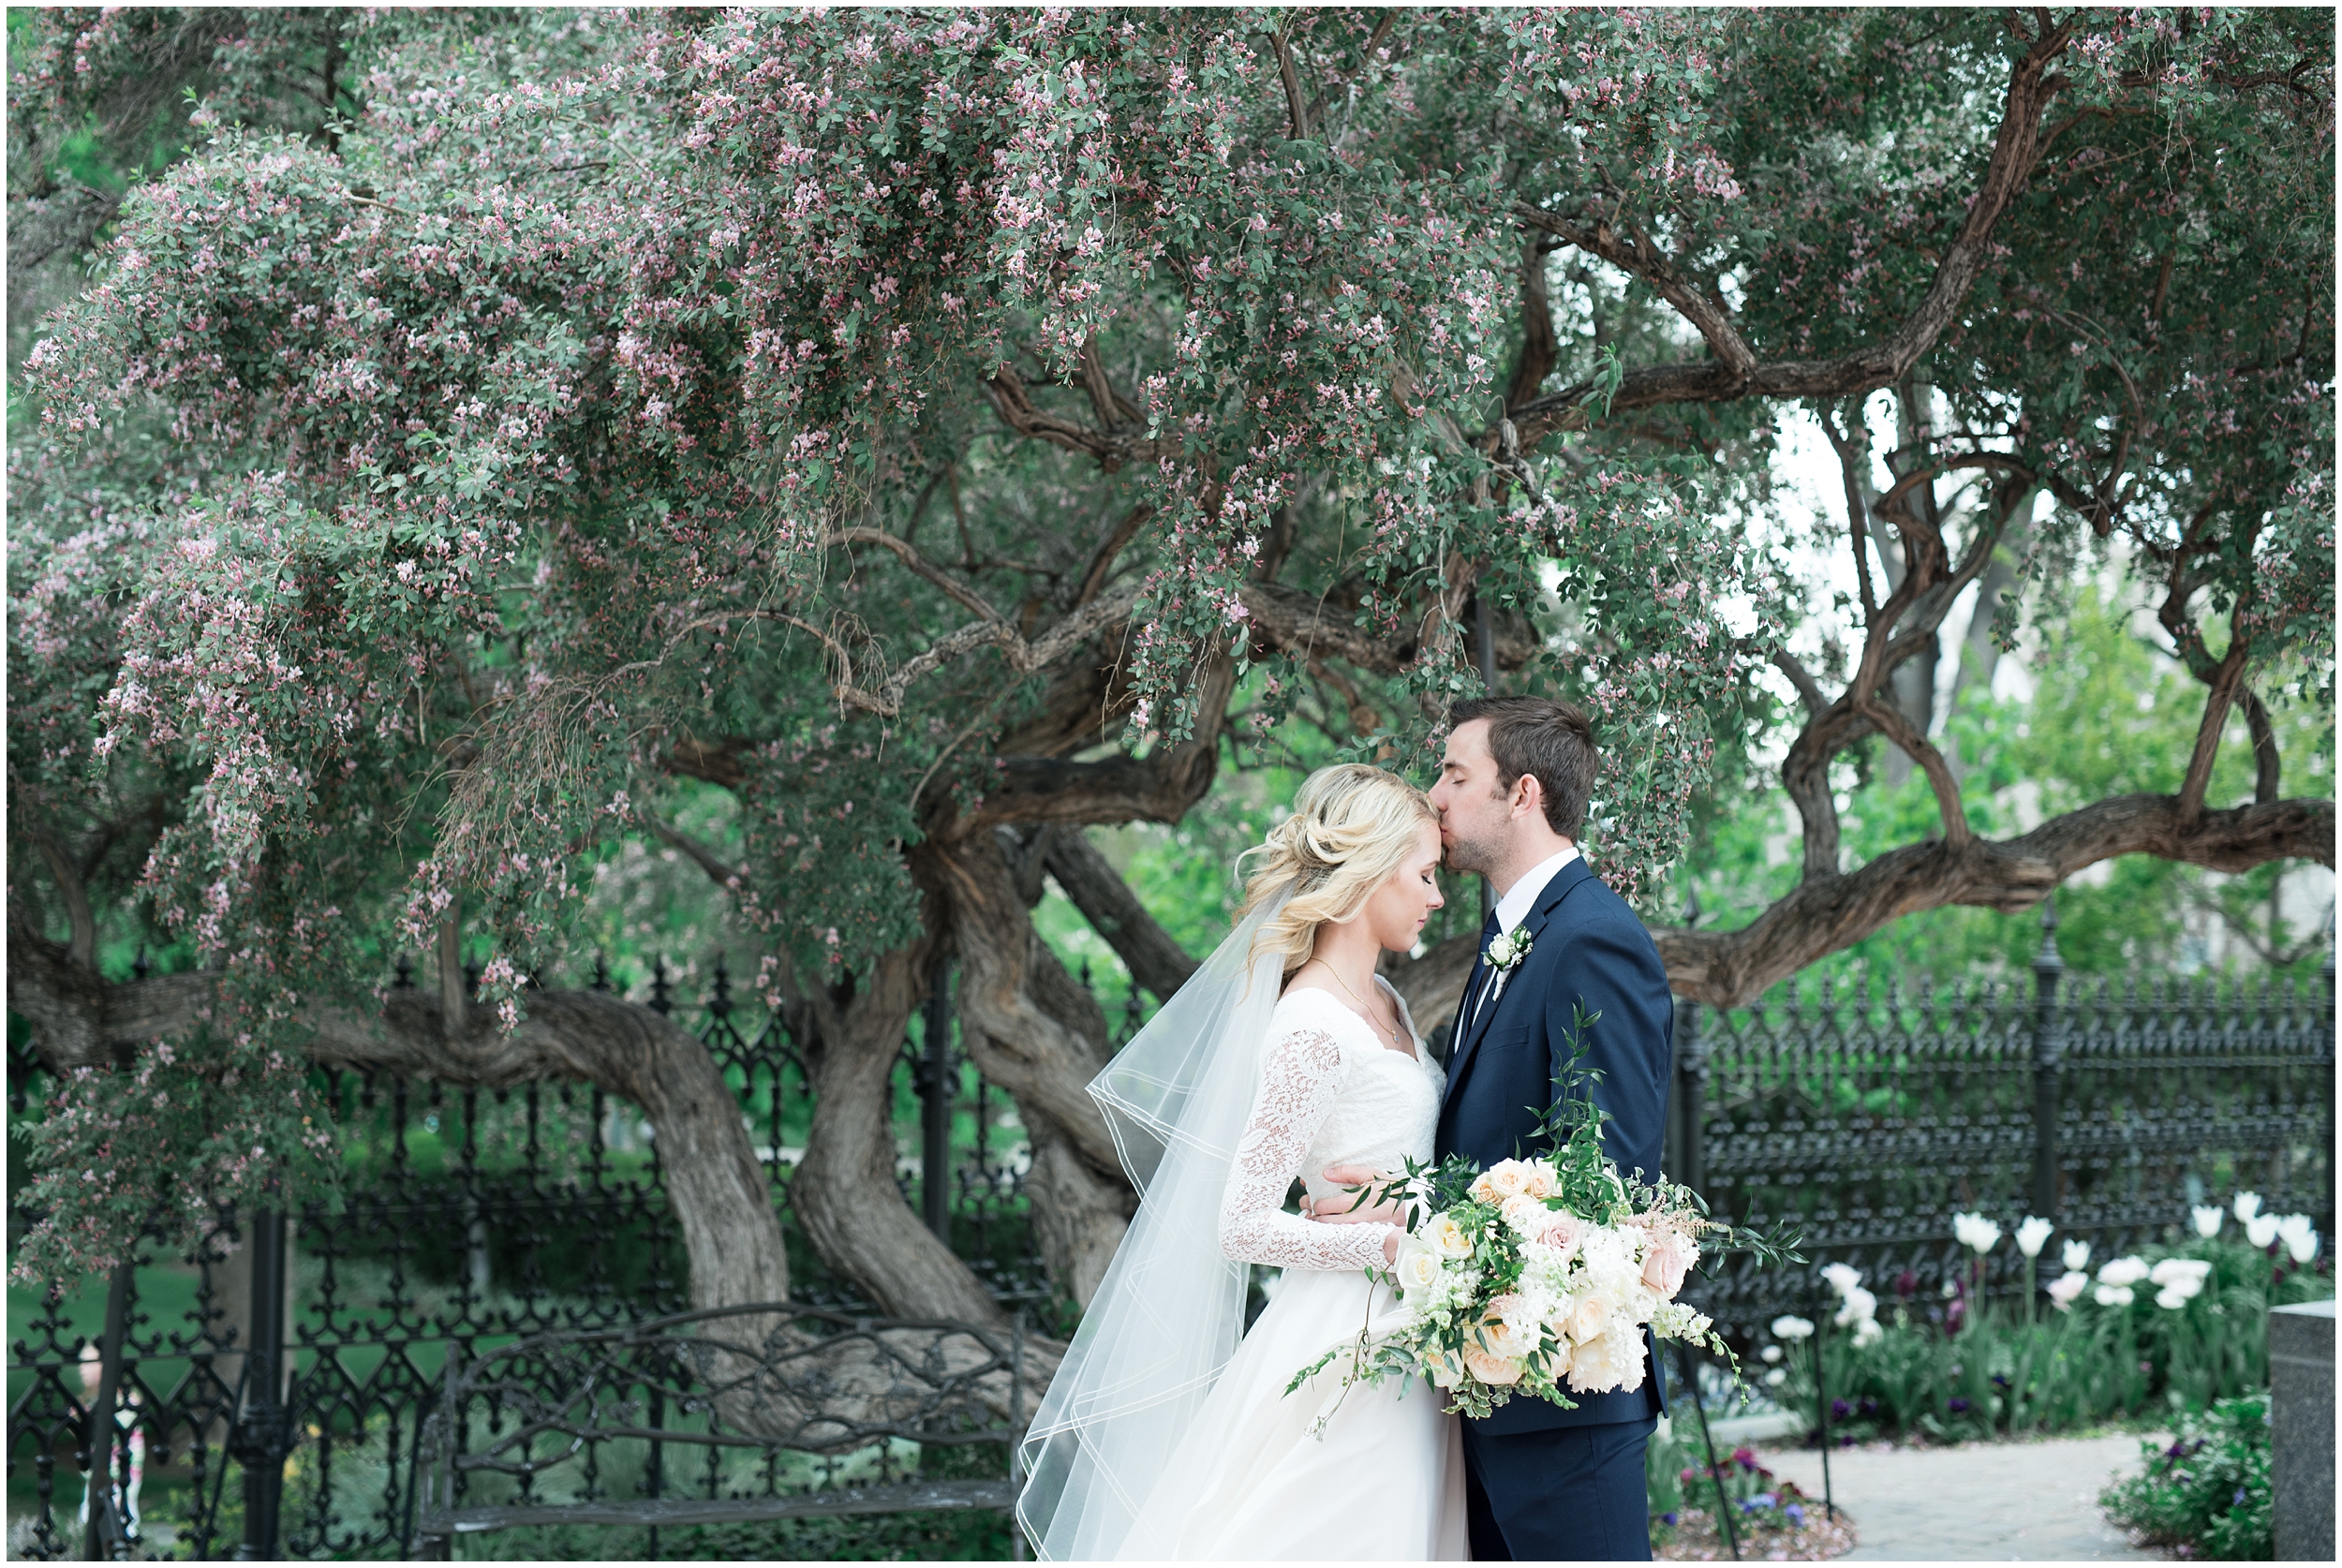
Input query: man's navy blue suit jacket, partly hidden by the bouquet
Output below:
<box><xmin>1436</xmin><ymin>856</ymin><xmax>1675</xmax><ymax>1435</ymax></box>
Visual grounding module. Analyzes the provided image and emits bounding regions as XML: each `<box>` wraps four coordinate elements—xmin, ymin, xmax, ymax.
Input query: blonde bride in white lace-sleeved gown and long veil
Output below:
<box><xmin>1016</xmin><ymin>765</ymin><xmax>1469</xmax><ymax>1561</ymax></box>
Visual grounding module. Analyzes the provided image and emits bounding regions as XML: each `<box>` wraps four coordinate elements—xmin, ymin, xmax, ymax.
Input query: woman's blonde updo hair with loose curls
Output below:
<box><xmin>1237</xmin><ymin>763</ymin><xmax>1441</xmax><ymax>976</ymax></box>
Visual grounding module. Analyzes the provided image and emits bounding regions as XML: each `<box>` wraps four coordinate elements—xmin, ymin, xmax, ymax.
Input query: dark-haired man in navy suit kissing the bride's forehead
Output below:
<box><xmin>1321</xmin><ymin>698</ymin><xmax>1675</xmax><ymax>1561</ymax></box>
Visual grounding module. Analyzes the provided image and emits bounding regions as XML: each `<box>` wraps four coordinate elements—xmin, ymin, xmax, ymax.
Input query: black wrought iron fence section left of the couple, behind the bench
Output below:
<box><xmin>9</xmin><ymin>962</ymin><xmax>1073</xmax><ymax>1559</ymax></box>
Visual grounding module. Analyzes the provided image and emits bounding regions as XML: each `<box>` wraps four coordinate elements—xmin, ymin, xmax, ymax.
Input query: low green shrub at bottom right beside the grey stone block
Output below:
<box><xmin>2098</xmin><ymin>1395</ymin><xmax>2276</xmax><ymax>1561</ymax></box>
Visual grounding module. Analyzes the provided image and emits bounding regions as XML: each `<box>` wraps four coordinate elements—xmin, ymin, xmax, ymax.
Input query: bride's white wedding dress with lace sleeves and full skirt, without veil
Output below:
<box><xmin>1118</xmin><ymin>985</ymin><xmax>1471</xmax><ymax>1561</ymax></box>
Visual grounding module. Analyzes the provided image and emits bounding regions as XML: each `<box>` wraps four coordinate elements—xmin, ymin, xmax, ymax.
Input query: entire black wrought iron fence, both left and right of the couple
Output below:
<box><xmin>9</xmin><ymin>922</ymin><xmax>2335</xmax><ymax>1559</ymax></box>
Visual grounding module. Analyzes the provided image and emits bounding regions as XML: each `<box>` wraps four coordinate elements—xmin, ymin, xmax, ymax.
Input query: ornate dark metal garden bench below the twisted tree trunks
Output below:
<box><xmin>420</xmin><ymin>1304</ymin><xmax>1030</xmax><ymax>1557</ymax></box>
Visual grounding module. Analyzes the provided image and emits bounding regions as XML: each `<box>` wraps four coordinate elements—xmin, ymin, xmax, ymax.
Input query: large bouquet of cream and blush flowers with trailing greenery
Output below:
<box><xmin>1286</xmin><ymin>1018</ymin><xmax>1797</xmax><ymax>1427</ymax></box>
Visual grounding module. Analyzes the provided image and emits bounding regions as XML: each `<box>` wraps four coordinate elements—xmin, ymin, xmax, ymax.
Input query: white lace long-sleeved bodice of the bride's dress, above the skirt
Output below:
<box><xmin>1221</xmin><ymin>990</ymin><xmax>1441</xmax><ymax>1268</ymax></box>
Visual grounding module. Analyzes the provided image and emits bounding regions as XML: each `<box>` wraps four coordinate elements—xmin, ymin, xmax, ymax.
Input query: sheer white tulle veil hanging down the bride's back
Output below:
<box><xmin>1016</xmin><ymin>896</ymin><xmax>1283</xmax><ymax>1561</ymax></box>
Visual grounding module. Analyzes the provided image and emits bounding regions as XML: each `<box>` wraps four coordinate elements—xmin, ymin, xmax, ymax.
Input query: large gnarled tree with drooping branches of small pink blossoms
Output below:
<box><xmin>9</xmin><ymin>11</ymin><xmax>2333</xmax><ymax>1320</ymax></box>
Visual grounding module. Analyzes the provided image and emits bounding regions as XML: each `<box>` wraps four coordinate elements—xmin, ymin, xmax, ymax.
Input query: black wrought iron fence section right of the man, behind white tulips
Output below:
<box><xmin>1668</xmin><ymin>915</ymin><xmax>2335</xmax><ymax>1332</ymax></box>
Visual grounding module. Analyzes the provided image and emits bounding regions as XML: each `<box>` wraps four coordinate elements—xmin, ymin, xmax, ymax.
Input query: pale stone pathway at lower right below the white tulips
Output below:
<box><xmin>1759</xmin><ymin>1432</ymin><xmax>2159</xmax><ymax>1563</ymax></box>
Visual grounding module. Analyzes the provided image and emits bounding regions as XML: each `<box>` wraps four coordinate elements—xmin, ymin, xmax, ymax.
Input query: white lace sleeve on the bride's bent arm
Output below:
<box><xmin>1221</xmin><ymin>1029</ymin><xmax>1391</xmax><ymax>1268</ymax></box>
